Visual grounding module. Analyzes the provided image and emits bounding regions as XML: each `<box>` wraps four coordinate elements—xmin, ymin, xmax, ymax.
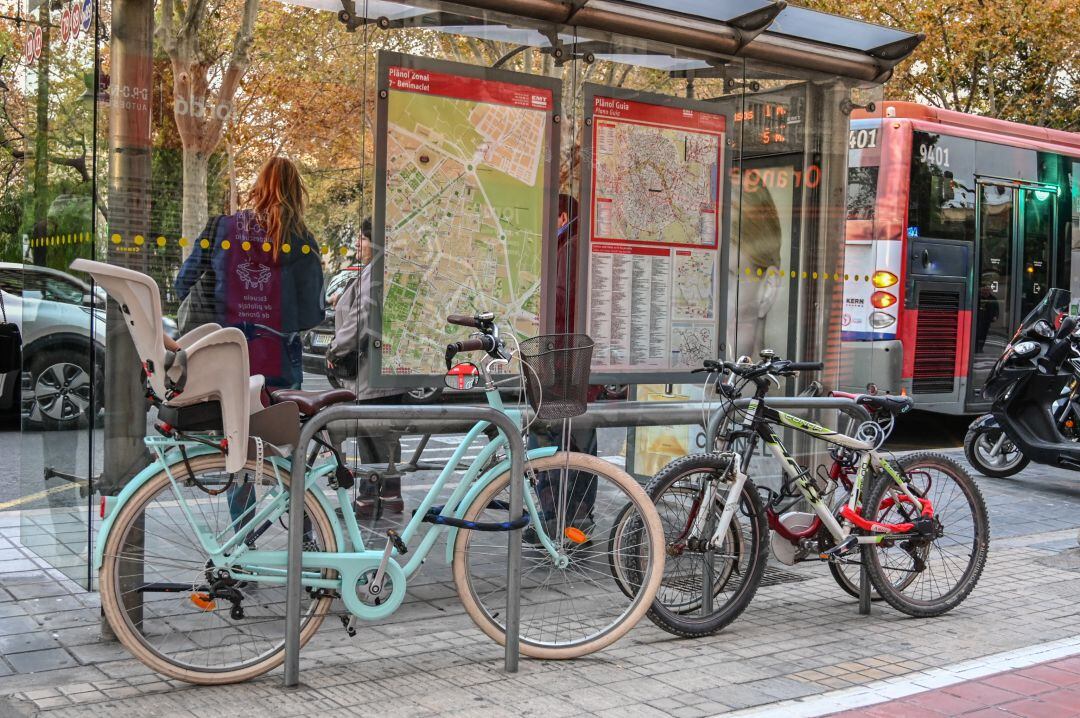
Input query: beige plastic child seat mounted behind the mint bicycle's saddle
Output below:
<box><xmin>71</xmin><ymin>259</ymin><xmax>255</xmax><ymax>472</ymax></box>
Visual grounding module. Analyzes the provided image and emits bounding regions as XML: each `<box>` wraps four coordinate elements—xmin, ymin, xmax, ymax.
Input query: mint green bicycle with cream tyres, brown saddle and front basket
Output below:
<box><xmin>96</xmin><ymin>314</ymin><xmax>663</xmax><ymax>685</ymax></box>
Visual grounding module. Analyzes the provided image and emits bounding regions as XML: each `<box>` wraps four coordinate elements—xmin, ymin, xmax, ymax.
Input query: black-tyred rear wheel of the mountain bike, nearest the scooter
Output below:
<box><xmin>862</xmin><ymin>452</ymin><xmax>989</xmax><ymax>618</ymax></box>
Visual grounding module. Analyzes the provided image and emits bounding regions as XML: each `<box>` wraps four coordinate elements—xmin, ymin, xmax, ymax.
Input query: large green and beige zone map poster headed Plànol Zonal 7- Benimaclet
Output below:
<box><xmin>370</xmin><ymin>52</ymin><xmax>559</xmax><ymax>387</ymax></box>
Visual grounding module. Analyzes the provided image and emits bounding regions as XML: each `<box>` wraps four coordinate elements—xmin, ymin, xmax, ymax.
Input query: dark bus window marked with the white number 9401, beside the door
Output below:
<box><xmin>907</xmin><ymin>132</ymin><xmax>975</xmax><ymax>240</ymax></box>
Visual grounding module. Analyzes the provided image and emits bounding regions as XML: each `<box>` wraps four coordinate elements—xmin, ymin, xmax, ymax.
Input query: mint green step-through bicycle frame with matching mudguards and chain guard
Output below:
<box><xmin>97</xmin><ymin>367</ymin><xmax>565</xmax><ymax>620</ymax></box>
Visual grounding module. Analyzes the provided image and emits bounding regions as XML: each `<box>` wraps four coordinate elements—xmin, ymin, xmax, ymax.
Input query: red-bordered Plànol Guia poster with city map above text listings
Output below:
<box><xmin>579</xmin><ymin>85</ymin><xmax>729</xmax><ymax>381</ymax></box>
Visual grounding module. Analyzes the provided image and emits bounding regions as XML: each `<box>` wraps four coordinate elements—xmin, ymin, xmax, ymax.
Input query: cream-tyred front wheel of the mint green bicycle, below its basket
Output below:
<box><xmin>454</xmin><ymin>451</ymin><xmax>664</xmax><ymax>659</ymax></box>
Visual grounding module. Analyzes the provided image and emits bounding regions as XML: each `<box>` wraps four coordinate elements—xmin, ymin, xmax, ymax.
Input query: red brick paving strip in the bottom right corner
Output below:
<box><xmin>831</xmin><ymin>656</ymin><xmax>1080</xmax><ymax>718</ymax></box>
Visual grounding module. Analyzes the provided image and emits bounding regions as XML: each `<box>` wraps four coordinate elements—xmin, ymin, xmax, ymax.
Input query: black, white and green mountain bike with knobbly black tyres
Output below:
<box><xmin>611</xmin><ymin>352</ymin><xmax>988</xmax><ymax>636</ymax></box>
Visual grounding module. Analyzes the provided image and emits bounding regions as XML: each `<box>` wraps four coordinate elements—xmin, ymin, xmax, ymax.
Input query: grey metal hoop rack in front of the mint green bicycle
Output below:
<box><xmin>285</xmin><ymin>404</ymin><xmax>525</xmax><ymax>688</ymax></box>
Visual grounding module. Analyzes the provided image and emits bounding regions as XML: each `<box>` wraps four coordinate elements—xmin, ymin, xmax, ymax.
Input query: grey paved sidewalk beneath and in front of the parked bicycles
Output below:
<box><xmin>0</xmin><ymin>444</ymin><xmax>1080</xmax><ymax>718</ymax></box>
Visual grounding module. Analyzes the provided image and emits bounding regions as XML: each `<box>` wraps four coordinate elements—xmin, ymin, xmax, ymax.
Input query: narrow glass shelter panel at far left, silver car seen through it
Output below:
<box><xmin>13</xmin><ymin>3</ymin><xmax>101</xmax><ymax>586</ymax></box>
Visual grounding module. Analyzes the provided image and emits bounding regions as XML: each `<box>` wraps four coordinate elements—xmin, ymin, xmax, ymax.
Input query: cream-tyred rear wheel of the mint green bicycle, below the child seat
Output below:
<box><xmin>100</xmin><ymin>455</ymin><xmax>337</xmax><ymax>685</ymax></box>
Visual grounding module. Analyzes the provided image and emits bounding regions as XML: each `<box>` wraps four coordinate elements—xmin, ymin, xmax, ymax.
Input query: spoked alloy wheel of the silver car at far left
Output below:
<box><xmin>23</xmin><ymin>349</ymin><xmax>104</xmax><ymax>431</ymax></box>
